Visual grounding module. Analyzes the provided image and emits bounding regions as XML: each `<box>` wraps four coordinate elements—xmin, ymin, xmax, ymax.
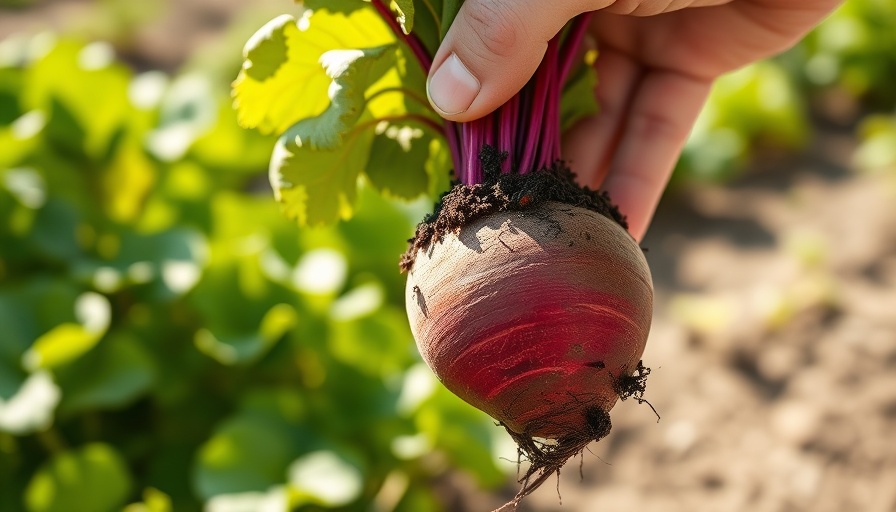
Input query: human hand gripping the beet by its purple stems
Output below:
<box><xmin>427</xmin><ymin>0</ymin><xmax>840</xmax><ymax>240</ymax></box>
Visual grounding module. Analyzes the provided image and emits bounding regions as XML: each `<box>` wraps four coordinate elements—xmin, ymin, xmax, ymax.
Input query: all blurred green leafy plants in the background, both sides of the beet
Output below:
<box><xmin>0</xmin><ymin>0</ymin><xmax>896</xmax><ymax>512</ymax></box>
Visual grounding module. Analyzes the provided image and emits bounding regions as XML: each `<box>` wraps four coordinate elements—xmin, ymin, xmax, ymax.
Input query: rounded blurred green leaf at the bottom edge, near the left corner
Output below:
<box><xmin>25</xmin><ymin>443</ymin><xmax>131</xmax><ymax>512</ymax></box>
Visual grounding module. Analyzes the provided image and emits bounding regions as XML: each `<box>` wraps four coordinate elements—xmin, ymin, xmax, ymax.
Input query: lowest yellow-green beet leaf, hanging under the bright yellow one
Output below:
<box><xmin>270</xmin><ymin>119</ymin><xmax>374</xmax><ymax>226</ymax></box>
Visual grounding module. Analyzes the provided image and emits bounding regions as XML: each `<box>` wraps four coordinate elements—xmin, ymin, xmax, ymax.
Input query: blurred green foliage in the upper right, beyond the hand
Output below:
<box><xmin>675</xmin><ymin>0</ymin><xmax>896</xmax><ymax>183</ymax></box>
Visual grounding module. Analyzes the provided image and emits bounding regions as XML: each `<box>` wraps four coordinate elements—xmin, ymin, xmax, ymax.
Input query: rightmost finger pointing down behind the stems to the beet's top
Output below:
<box><xmin>590</xmin><ymin>70</ymin><xmax>711</xmax><ymax>240</ymax></box>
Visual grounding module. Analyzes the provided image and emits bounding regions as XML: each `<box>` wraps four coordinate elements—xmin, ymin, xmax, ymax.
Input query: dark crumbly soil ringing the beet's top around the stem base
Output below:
<box><xmin>399</xmin><ymin>146</ymin><xmax>628</xmax><ymax>272</ymax></box>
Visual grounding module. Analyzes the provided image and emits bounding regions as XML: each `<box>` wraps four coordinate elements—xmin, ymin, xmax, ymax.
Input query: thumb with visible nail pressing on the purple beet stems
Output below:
<box><xmin>426</xmin><ymin>0</ymin><xmax>606</xmax><ymax>121</ymax></box>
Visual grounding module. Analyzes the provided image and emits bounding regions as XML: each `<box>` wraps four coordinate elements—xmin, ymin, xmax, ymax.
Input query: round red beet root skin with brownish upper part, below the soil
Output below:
<box><xmin>407</xmin><ymin>203</ymin><xmax>653</xmax><ymax>439</ymax></box>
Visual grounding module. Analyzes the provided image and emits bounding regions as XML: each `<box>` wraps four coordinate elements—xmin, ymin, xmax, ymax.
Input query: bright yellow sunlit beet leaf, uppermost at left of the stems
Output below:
<box><xmin>233</xmin><ymin>9</ymin><xmax>395</xmax><ymax>133</ymax></box>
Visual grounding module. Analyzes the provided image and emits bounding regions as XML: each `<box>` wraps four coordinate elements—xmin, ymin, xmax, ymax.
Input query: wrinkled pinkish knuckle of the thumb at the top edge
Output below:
<box><xmin>464</xmin><ymin>0</ymin><xmax>522</xmax><ymax>60</ymax></box>
